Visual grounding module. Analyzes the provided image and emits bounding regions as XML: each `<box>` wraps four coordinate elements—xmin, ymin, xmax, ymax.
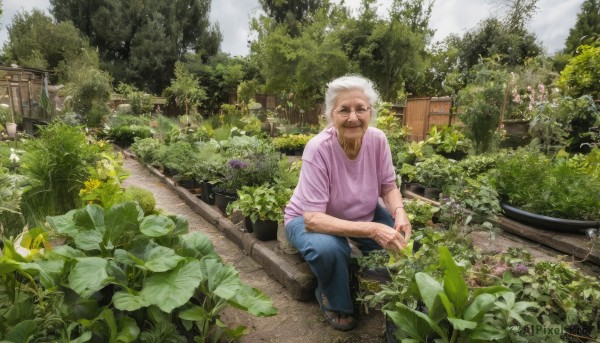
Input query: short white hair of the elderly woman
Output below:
<box><xmin>324</xmin><ymin>75</ymin><xmax>379</xmax><ymax>122</ymax></box>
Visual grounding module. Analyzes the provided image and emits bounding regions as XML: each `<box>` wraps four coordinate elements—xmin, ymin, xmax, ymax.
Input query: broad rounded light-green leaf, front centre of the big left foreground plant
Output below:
<box><xmin>140</xmin><ymin>260</ymin><xmax>205</xmax><ymax>313</ymax></box>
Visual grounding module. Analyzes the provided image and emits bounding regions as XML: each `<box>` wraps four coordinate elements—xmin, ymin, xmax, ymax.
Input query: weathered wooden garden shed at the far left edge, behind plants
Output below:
<box><xmin>0</xmin><ymin>66</ymin><xmax>52</xmax><ymax>133</ymax></box>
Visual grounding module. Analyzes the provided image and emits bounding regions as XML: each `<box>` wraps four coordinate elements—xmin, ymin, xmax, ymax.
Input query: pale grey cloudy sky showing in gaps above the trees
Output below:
<box><xmin>0</xmin><ymin>0</ymin><xmax>583</xmax><ymax>55</ymax></box>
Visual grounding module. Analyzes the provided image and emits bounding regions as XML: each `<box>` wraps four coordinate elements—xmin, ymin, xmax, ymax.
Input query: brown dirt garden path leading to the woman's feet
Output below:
<box><xmin>123</xmin><ymin>158</ymin><xmax>385</xmax><ymax>343</ymax></box>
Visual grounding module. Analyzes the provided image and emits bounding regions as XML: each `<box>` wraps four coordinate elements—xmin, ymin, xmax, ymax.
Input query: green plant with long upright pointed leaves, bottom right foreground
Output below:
<box><xmin>385</xmin><ymin>246</ymin><xmax>539</xmax><ymax>343</ymax></box>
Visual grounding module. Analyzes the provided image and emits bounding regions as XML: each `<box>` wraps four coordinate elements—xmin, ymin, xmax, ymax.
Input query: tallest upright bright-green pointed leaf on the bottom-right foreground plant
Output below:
<box><xmin>439</xmin><ymin>246</ymin><xmax>469</xmax><ymax>317</ymax></box>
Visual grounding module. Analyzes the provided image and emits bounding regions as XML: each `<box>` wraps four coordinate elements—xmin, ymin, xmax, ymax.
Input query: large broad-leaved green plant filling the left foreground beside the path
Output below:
<box><xmin>0</xmin><ymin>202</ymin><xmax>277</xmax><ymax>342</ymax></box>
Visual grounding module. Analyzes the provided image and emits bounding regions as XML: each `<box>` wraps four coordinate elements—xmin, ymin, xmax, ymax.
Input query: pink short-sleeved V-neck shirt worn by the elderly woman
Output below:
<box><xmin>284</xmin><ymin>127</ymin><xmax>396</xmax><ymax>225</ymax></box>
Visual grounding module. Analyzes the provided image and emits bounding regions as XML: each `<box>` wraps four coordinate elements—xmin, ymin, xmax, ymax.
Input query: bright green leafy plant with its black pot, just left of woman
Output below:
<box><xmin>227</xmin><ymin>184</ymin><xmax>292</xmax><ymax>241</ymax></box>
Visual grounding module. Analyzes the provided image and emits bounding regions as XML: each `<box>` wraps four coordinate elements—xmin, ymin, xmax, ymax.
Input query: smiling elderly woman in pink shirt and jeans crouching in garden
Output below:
<box><xmin>285</xmin><ymin>76</ymin><xmax>411</xmax><ymax>330</ymax></box>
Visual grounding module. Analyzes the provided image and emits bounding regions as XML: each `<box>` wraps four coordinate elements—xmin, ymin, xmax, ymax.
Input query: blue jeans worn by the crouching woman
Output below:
<box><xmin>285</xmin><ymin>205</ymin><xmax>394</xmax><ymax>314</ymax></box>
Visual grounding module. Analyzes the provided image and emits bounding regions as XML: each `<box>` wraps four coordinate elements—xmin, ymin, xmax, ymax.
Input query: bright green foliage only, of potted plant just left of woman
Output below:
<box><xmin>227</xmin><ymin>185</ymin><xmax>292</xmax><ymax>223</ymax></box>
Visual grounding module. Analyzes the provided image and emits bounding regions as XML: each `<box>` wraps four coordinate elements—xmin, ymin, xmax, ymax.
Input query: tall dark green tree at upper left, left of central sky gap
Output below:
<box><xmin>50</xmin><ymin>0</ymin><xmax>222</xmax><ymax>93</ymax></box>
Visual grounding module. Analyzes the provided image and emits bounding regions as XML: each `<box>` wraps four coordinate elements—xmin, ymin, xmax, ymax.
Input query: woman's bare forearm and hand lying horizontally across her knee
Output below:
<box><xmin>304</xmin><ymin>211</ymin><xmax>407</xmax><ymax>250</ymax></box>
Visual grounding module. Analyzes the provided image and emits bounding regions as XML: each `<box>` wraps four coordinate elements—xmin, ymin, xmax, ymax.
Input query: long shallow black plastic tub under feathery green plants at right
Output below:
<box><xmin>500</xmin><ymin>203</ymin><xmax>600</xmax><ymax>233</ymax></box>
